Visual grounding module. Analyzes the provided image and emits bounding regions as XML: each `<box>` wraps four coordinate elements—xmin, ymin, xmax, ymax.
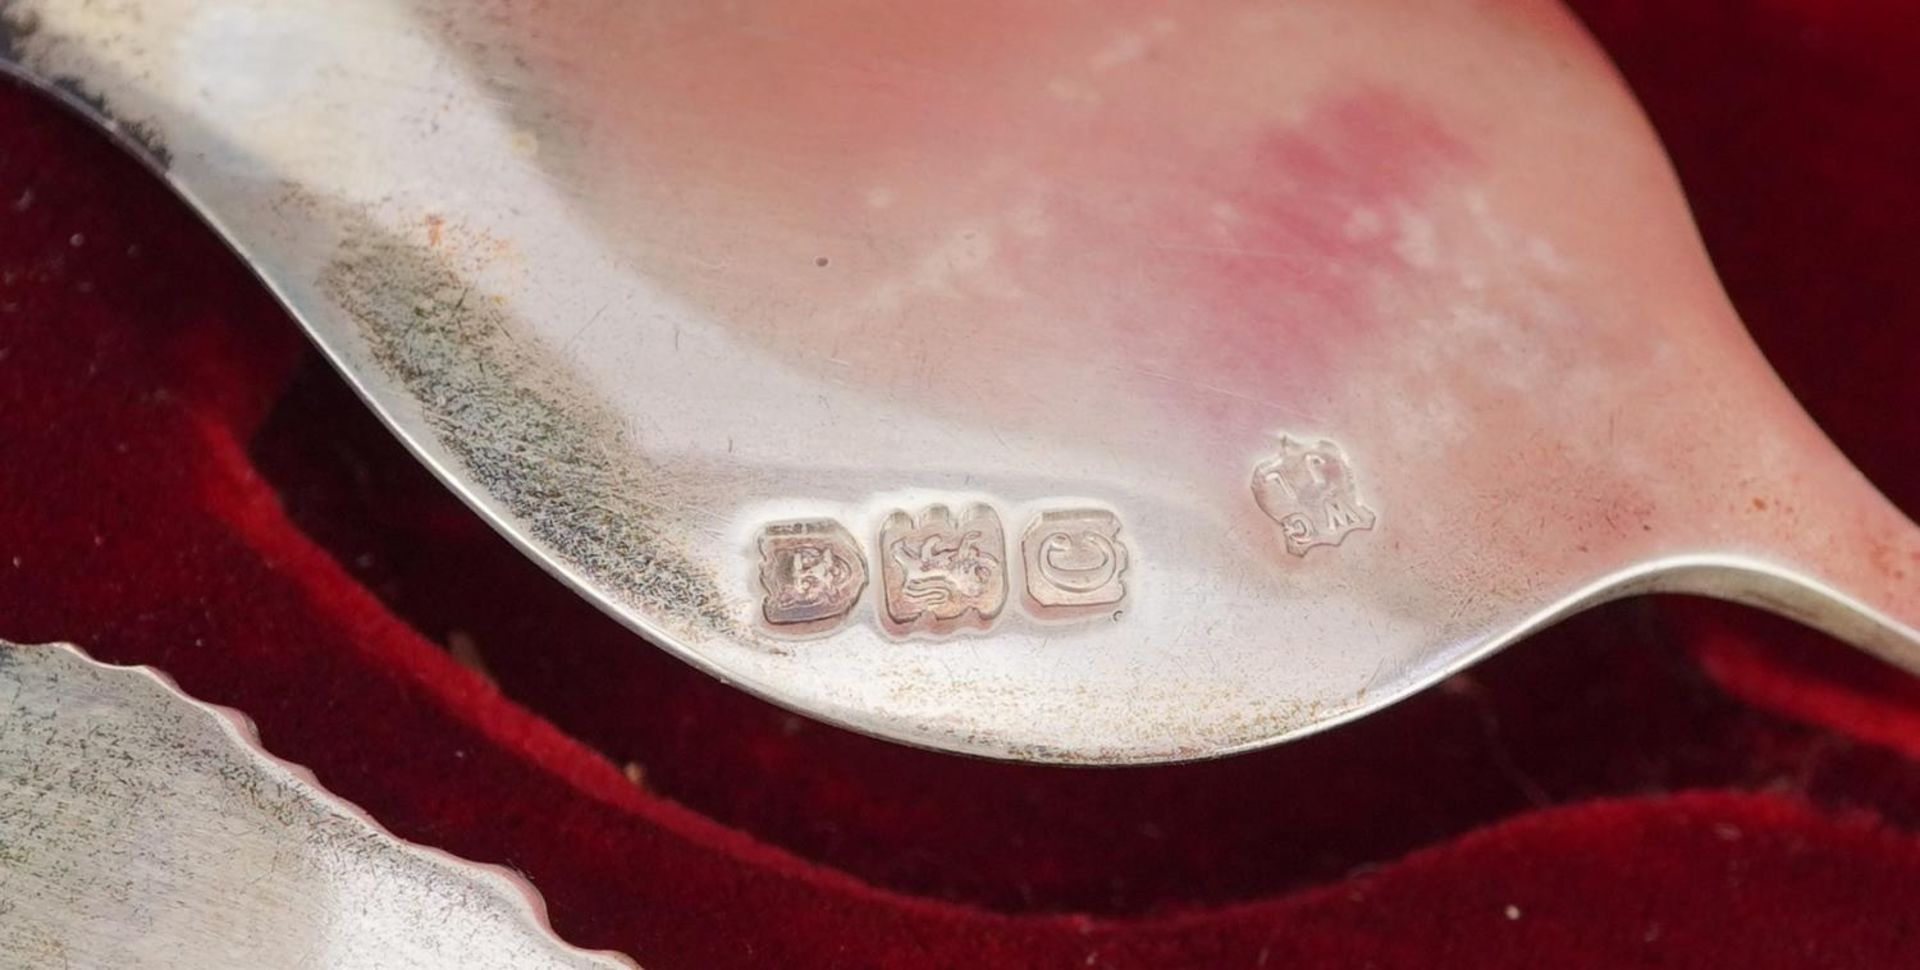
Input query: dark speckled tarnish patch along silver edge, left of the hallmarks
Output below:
<box><xmin>314</xmin><ymin>221</ymin><xmax>735</xmax><ymax>634</ymax></box>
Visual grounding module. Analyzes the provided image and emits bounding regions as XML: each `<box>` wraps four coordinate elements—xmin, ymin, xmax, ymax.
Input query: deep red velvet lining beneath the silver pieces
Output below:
<box><xmin>0</xmin><ymin>0</ymin><xmax>1920</xmax><ymax>968</ymax></box>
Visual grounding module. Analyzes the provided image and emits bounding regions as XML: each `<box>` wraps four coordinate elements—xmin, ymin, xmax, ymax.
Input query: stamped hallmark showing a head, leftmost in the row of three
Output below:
<box><xmin>760</xmin><ymin>519</ymin><xmax>866</xmax><ymax>626</ymax></box>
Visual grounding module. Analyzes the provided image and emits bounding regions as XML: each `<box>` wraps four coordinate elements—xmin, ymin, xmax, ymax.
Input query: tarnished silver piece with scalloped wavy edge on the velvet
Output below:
<box><xmin>0</xmin><ymin>642</ymin><xmax>636</xmax><ymax>970</ymax></box>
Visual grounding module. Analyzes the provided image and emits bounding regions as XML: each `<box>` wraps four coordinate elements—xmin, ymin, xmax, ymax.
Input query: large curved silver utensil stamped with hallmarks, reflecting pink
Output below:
<box><xmin>0</xmin><ymin>0</ymin><xmax>1920</xmax><ymax>763</ymax></box>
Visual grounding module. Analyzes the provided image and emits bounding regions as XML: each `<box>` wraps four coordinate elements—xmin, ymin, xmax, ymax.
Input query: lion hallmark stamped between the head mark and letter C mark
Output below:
<box><xmin>879</xmin><ymin>505</ymin><xmax>1006</xmax><ymax>626</ymax></box>
